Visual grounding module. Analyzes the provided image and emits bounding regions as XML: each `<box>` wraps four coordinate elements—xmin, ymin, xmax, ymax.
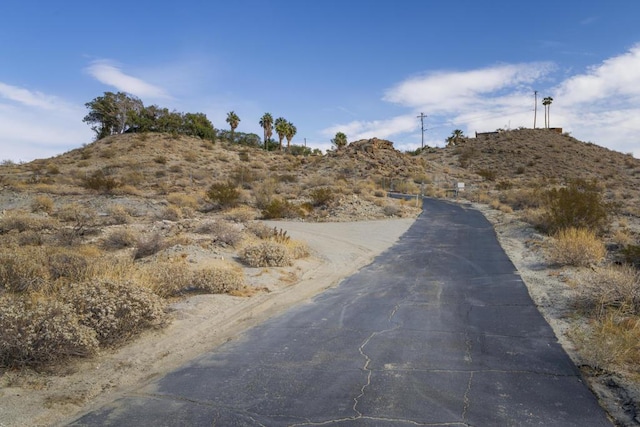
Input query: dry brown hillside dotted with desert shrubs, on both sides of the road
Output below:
<box><xmin>0</xmin><ymin>129</ymin><xmax>640</xmax><ymax>427</ymax></box>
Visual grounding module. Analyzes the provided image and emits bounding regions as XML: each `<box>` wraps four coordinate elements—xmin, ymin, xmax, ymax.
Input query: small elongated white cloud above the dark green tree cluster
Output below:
<box><xmin>87</xmin><ymin>60</ymin><xmax>170</xmax><ymax>99</ymax></box>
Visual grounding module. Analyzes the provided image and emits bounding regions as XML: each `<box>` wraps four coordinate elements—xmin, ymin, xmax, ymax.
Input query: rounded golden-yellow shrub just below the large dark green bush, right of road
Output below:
<box><xmin>547</xmin><ymin>227</ymin><xmax>607</xmax><ymax>267</ymax></box>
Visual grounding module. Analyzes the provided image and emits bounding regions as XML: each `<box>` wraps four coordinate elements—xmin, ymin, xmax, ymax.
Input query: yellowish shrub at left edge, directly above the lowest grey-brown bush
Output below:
<box><xmin>0</xmin><ymin>247</ymin><xmax>49</xmax><ymax>292</ymax></box>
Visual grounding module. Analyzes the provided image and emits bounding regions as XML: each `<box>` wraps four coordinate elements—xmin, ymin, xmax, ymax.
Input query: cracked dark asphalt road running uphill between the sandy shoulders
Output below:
<box><xmin>71</xmin><ymin>200</ymin><xmax>612</xmax><ymax>427</ymax></box>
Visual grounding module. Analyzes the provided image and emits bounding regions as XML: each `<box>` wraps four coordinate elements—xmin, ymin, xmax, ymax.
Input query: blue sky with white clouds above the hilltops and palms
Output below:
<box><xmin>0</xmin><ymin>0</ymin><xmax>640</xmax><ymax>161</ymax></box>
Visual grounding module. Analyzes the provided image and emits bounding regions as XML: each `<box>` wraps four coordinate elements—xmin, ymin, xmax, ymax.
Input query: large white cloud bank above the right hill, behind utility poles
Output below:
<box><xmin>323</xmin><ymin>44</ymin><xmax>640</xmax><ymax>157</ymax></box>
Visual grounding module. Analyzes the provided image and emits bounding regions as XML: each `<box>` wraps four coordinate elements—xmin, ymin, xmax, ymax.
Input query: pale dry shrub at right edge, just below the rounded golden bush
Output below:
<box><xmin>574</xmin><ymin>265</ymin><xmax>640</xmax><ymax>317</ymax></box>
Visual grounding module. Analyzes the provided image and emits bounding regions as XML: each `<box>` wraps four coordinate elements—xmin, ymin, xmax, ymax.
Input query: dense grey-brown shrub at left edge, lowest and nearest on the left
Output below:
<box><xmin>0</xmin><ymin>295</ymin><xmax>98</xmax><ymax>367</ymax></box>
